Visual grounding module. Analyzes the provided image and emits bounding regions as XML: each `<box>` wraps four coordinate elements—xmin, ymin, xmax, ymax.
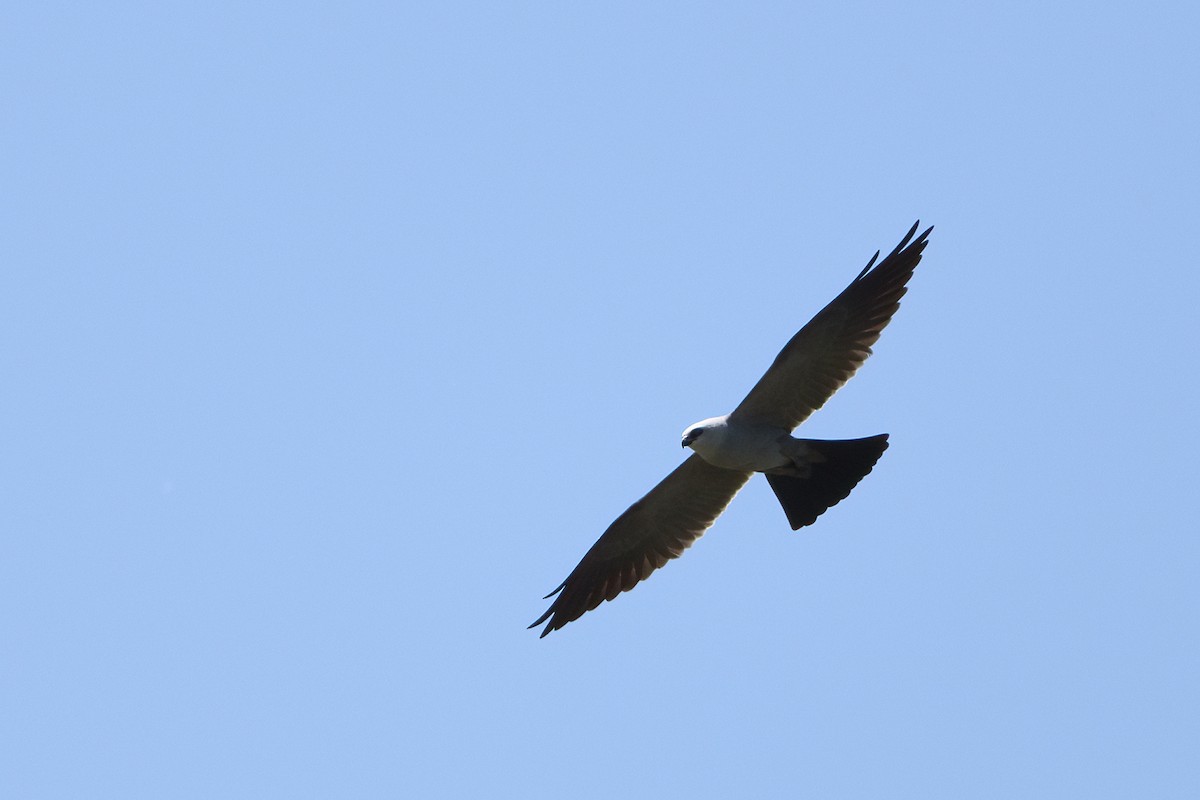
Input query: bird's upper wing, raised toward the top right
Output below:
<box><xmin>730</xmin><ymin>221</ymin><xmax>932</xmax><ymax>431</ymax></box>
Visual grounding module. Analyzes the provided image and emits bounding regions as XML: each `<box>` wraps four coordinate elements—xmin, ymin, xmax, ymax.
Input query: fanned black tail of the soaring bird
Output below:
<box><xmin>767</xmin><ymin>433</ymin><xmax>888</xmax><ymax>530</ymax></box>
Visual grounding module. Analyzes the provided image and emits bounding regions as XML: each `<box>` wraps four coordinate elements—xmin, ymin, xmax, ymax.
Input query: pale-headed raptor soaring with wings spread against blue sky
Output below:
<box><xmin>529</xmin><ymin>221</ymin><xmax>932</xmax><ymax>636</ymax></box>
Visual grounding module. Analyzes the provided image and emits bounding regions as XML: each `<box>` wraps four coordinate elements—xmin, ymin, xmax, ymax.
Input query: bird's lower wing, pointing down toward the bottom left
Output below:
<box><xmin>529</xmin><ymin>455</ymin><xmax>752</xmax><ymax>636</ymax></box>
